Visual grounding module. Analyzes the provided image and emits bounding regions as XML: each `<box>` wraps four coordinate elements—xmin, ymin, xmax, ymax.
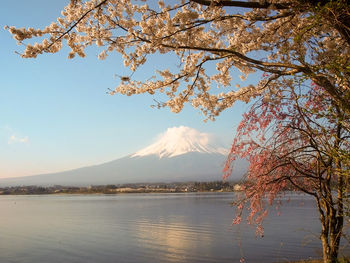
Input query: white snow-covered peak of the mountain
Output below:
<box><xmin>131</xmin><ymin>126</ymin><xmax>228</xmax><ymax>158</ymax></box>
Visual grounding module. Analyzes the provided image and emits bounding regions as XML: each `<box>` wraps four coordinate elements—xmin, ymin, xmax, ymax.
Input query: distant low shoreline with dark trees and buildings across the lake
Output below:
<box><xmin>0</xmin><ymin>181</ymin><xmax>237</xmax><ymax>195</ymax></box>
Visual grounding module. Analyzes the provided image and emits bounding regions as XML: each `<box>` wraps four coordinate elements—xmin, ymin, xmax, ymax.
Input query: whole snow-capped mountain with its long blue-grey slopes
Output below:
<box><xmin>0</xmin><ymin>126</ymin><xmax>247</xmax><ymax>186</ymax></box>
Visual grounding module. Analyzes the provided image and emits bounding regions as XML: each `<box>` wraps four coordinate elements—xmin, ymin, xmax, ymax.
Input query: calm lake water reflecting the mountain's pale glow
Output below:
<box><xmin>0</xmin><ymin>193</ymin><xmax>348</xmax><ymax>263</ymax></box>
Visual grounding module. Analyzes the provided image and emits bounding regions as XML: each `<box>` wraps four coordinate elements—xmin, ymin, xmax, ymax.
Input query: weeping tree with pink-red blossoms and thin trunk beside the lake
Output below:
<box><xmin>225</xmin><ymin>79</ymin><xmax>350</xmax><ymax>263</ymax></box>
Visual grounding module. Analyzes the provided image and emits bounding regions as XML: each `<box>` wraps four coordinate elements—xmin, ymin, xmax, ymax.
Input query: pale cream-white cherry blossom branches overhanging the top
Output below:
<box><xmin>6</xmin><ymin>0</ymin><xmax>350</xmax><ymax>119</ymax></box>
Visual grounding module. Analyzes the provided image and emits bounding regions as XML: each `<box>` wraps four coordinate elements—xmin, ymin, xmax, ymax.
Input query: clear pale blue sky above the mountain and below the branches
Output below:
<box><xmin>0</xmin><ymin>0</ymin><xmax>252</xmax><ymax>178</ymax></box>
